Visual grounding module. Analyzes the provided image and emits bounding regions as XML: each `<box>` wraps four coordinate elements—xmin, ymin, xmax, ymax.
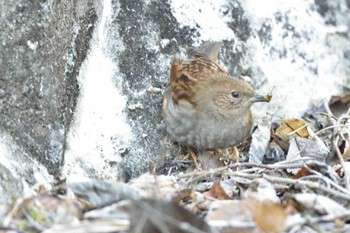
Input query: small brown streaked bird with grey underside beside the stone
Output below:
<box><xmin>163</xmin><ymin>42</ymin><xmax>271</xmax><ymax>153</ymax></box>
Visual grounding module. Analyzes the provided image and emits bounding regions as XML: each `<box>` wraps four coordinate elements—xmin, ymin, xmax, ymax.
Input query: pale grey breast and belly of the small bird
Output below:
<box><xmin>165</xmin><ymin>98</ymin><xmax>252</xmax><ymax>149</ymax></box>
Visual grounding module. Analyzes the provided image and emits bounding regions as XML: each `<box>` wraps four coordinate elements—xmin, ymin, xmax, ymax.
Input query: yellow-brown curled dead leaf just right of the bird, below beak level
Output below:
<box><xmin>276</xmin><ymin>119</ymin><xmax>310</xmax><ymax>141</ymax></box>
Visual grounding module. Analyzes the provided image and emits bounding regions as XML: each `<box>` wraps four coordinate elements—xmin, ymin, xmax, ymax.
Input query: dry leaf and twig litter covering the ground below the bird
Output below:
<box><xmin>0</xmin><ymin>95</ymin><xmax>350</xmax><ymax>233</ymax></box>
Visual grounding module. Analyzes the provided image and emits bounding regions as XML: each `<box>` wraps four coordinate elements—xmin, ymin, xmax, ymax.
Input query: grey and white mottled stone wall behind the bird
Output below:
<box><xmin>0</xmin><ymin>0</ymin><xmax>350</xmax><ymax>201</ymax></box>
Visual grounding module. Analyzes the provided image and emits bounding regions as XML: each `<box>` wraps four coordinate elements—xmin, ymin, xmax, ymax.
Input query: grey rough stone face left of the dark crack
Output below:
<box><xmin>0</xmin><ymin>0</ymin><xmax>96</xmax><ymax>198</ymax></box>
